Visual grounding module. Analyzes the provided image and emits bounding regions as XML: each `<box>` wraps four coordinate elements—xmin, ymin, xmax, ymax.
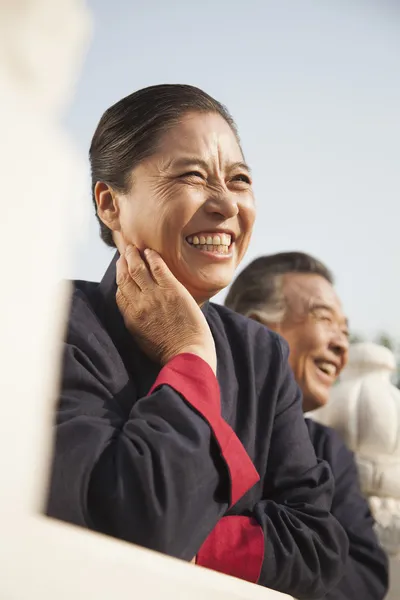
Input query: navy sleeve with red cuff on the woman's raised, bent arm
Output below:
<box><xmin>47</xmin><ymin>322</ymin><xmax>259</xmax><ymax>560</ymax></box>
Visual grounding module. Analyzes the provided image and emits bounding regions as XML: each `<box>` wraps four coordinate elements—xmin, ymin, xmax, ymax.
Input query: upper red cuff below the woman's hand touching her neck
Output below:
<box><xmin>149</xmin><ymin>353</ymin><xmax>260</xmax><ymax>506</ymax></box>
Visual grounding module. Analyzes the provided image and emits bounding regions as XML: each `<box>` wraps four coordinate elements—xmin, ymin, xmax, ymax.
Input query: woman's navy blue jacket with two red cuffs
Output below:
<box><xmin>47</xmin><ymin>258</ymin><xmax>348</xmax><ymax>600</ymax></box>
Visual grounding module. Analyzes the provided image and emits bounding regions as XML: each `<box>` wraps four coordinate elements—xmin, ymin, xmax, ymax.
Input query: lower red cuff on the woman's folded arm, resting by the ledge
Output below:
<box><xmin>196</xmin><ymin>516</ymin><xmax>265</xmax><ymax>583</ymax></box>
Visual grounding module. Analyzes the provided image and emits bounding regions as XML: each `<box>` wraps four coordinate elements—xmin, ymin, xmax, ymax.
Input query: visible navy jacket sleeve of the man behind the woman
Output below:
<box><xmin>326</xmin><ymin>431</ymin><xmax>389</xmax><ymax>600</ymax></box>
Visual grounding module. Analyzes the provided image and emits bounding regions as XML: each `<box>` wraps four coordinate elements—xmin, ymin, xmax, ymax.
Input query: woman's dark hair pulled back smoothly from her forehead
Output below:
<box><xmin>89</xmin><ymin>84</ymin><xmax>240</xmax><ymax>247</ymax></box>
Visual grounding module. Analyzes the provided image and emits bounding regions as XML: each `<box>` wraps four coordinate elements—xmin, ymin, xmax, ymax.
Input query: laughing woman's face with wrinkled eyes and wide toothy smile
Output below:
<box><xmin>108</xmin><ymin>113</ymin><xmax>255</xmax><ymax>302</ymax></box>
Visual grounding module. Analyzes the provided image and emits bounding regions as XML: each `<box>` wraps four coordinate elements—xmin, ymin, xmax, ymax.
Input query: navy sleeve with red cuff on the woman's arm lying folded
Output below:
<box><xmin>197</xmin><ymin>341</ymin><xmax>348</xmax><ymax>600</ymax></box>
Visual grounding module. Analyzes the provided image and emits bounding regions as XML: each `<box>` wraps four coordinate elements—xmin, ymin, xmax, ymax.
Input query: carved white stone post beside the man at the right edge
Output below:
<box><xmin>308</xmin><ymin>343</ymin><xmax>400</xmax><ymax>600</ymax></box>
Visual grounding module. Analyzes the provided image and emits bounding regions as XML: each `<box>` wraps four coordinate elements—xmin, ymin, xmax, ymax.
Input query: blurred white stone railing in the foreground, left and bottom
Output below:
<box><xmin>0</xmin><ymin>0</ymin><xmax>288</xmax><ymax>600</ymax></box>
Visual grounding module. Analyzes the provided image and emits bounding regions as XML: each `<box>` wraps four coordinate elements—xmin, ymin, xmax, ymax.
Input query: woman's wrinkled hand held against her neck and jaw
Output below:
<box><xmin>116</xmin><ymin>246</ymin><xmax>217</xmax><ymax>373</ymax></box>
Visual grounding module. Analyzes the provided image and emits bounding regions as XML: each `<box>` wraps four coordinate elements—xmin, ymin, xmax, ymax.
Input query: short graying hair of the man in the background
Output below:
<box><xmin>225</xmin><ymin>252</ymin><xmax>334</xmax><ymax>323</ymax></box>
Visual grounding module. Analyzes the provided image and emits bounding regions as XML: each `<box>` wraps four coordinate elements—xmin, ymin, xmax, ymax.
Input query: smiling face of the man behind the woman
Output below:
<box><xmin>279</xmin><ymin>273</ymin><xmax>349</xmax><ymax>412</ymax></box>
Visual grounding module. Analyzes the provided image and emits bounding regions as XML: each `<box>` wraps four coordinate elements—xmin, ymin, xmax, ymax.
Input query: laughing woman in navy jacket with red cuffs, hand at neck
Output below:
<box><xmin>47</xmin><ymin>85</ymin><xmax>348</xmax><ymax>600</ymax></box>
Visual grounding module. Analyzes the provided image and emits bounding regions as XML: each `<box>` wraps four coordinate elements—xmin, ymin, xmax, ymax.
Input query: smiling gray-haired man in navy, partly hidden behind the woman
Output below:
<box><xmin>226</xmin><ymin>252</ymin><xmax>388</xmax><ymax>600</ymax></box>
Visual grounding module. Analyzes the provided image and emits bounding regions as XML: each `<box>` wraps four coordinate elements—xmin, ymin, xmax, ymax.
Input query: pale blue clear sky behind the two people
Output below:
<box><xmin>66</xmin><ymin>0</ymin><xmax>400</xmax><ymax>337</ymax></box>
